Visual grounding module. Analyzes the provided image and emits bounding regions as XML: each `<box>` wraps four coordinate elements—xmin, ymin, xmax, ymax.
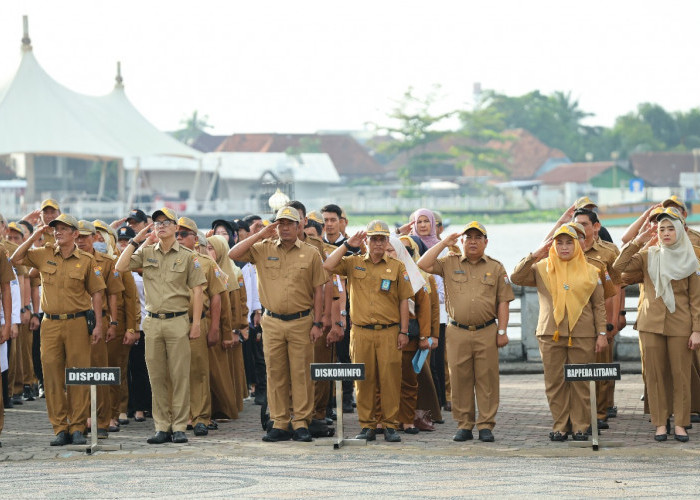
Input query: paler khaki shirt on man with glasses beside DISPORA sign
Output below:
<box><xmin>129</xmin><ymin>241</ymin><xmax>206</xmax><ymax>313</ymax></box>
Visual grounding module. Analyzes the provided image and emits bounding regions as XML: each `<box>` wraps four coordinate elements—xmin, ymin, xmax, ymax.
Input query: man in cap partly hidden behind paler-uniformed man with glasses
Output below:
<box><xmin>177</xmin><ymin>217</ymin><xmax>226</xmax><ymax>436</ymax></box>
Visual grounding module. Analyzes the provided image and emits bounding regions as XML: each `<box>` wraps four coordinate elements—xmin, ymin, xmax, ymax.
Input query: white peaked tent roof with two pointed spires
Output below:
<box><xmin>0</xmin><ymin>27</ymin><xmax>200</xmax><ymax>158</ymax></box>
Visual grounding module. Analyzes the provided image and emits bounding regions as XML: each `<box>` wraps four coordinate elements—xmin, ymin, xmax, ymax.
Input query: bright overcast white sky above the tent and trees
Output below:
<box><xmin>0</xmin><ymin>0</ymin><xmax>700</xmax><ymax>134</ymax></box>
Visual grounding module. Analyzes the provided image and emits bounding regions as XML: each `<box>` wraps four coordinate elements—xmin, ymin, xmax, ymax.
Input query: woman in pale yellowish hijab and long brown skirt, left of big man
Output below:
<box><xmin>207</xmin><ymin>235</ymin><xmax>239</xmax><ymax>418</ymax></box>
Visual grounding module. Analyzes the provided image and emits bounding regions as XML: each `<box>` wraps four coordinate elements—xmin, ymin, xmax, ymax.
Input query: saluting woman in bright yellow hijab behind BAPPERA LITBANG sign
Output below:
<box><xmin>511</xmin><ymin>225</ymin><xmax>608</xmax><ymax>441</ymax></box>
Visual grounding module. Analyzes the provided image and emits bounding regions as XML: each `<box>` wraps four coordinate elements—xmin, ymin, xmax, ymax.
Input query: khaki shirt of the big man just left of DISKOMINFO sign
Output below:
<box><xmin>238</xmin><ymin>238</ymin><xmax>328</xmax><ymax>312</ymax></box>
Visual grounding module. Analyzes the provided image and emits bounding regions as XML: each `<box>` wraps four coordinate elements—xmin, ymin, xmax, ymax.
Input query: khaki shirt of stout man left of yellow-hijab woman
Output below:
<box><xmin>433</xmin><ymin>254</ymin><xmax>515</xmax><ymax>325</ymax></box>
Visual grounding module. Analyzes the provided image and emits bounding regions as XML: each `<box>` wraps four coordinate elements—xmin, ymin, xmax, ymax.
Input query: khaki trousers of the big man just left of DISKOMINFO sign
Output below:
<box><xmin>261</xmin><ymin>314</ymin><xmax>314</xmax><ymax>430</ymax></box>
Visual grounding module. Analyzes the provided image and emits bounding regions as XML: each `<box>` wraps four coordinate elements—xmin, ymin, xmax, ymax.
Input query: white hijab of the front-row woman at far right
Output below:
<box><xmin>647</xmin><ymin>218</ymin><xmax>698</xmax><ymax>313</ymax></box>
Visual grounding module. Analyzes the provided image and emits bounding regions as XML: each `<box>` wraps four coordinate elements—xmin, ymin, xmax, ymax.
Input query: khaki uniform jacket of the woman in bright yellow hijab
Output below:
<box><xmin>510</xmin><ymin>254</ymin><xmax>606</xmax><ymax>337</ymax></box>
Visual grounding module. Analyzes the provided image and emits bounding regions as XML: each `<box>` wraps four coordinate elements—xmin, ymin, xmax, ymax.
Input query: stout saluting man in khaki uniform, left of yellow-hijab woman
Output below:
<box><xmin>418</xmin><ymin>221</ymin><xmax>515</xmax><ymax>442</ymax></box>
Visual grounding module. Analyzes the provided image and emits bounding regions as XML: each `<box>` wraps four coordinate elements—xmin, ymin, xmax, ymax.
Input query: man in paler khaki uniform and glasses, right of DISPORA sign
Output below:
<box><xmin>117</xmin><ymin>207</ymin><xmax>206</xmax><ymax>444</ymax></box>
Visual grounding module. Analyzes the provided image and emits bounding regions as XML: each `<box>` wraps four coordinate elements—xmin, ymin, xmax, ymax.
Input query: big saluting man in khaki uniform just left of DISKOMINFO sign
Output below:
<box><xmin>229</xmin><ymin>207</ymin><xmax>328</xmax><ymax>442</ymax></box>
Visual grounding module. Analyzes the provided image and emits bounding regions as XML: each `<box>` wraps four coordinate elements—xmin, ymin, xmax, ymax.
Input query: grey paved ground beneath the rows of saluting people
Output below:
<box><xmin>0</xmin><ymin>374</ymin><xmax>700</xmax><ymax>498</ymax></box>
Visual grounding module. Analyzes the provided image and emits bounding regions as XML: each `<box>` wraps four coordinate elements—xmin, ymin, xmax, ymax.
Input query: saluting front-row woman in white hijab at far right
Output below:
<box><xmin>613</xmin><ymin>208</ymin><xmax>700</xmax><ymax>442</ymax></box>
